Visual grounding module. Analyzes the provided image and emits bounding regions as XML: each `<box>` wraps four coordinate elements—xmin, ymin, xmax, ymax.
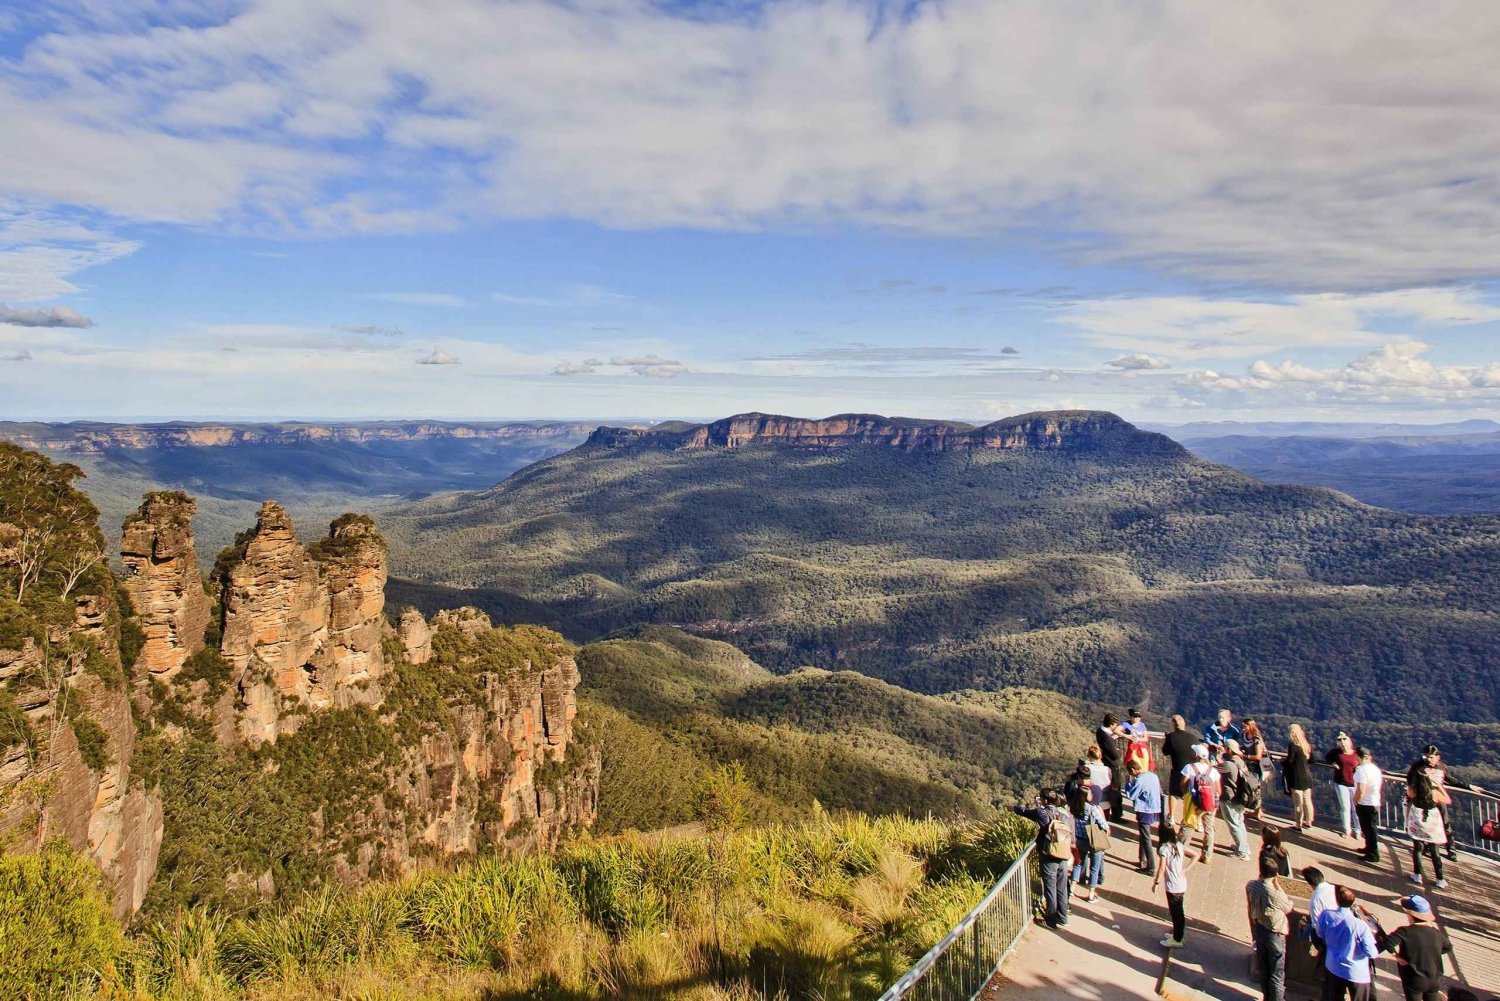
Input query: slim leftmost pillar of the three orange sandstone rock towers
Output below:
<box><xmin>120</xmin><ymin>491</ymin><xmax>210</xmax><ymax>681</ymax></box>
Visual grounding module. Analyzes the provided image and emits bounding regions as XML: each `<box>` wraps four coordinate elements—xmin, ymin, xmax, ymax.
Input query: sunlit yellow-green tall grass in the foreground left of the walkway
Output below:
<box><xmin>111</xmin><ymin>813</ymin><xmax>1032</xmax><ymax>1001</ymax></box>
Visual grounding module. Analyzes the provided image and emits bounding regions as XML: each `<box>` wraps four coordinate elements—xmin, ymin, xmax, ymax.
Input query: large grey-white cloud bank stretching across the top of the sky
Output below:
<box><xmin>0</xmin><ymin>0</ymin><xmax>1500</xmax><ymax>288</ymax></box>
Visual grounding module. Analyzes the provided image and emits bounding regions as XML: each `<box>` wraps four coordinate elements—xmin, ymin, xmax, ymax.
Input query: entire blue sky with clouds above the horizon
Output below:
<box><xmin>0</xmin><ymin>0</ymin><xmax>1500</xmax><ymax>422</ymax></box>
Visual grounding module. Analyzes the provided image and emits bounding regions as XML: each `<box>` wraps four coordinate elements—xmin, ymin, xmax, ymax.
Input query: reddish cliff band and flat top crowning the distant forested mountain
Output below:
<box><xmin>588</xmin><ymin>410</ymin><xmax>1187</xmax><ymax>455</ymax></box>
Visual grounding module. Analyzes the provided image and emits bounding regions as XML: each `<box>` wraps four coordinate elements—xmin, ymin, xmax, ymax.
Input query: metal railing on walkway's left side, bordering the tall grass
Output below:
<box><xmin>881</xmin><ymin>842</ymin><xmax>1037</xmax><ymax>1001</ymax></box>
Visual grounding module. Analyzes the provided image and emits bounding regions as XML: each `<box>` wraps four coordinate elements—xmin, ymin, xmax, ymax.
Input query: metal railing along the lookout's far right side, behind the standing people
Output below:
<box><xmin>1151</xmin><ymin>731</ymin><xmax>1500</xmax><ymax>860</ymax></box>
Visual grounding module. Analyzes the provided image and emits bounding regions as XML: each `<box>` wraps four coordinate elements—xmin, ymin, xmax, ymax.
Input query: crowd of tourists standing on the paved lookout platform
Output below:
<box><xmin>1016</xmin><ymin>708</ymin><xmax>1482</xmax><ymax>1001</ymax></box>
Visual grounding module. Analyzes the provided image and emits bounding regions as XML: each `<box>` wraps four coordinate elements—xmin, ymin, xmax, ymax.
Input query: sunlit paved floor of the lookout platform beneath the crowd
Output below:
<box><xmin>983</xmin><ymin>822</ymin><xmax>1500</xmax><ymax>1001</ymax></box>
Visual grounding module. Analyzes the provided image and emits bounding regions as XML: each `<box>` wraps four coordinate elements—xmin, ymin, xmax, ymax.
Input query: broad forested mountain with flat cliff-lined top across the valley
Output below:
<box><xmin>380</xmin><ymin>411</ymin><xmax>1500</xmax><ymax>732</ymax></box>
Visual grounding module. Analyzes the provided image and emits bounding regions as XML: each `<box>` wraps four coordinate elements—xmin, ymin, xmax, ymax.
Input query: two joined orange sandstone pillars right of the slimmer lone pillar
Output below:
<box><xmin>215</xmin><ymin>501</ymin><xmax>386</xmax><ymax>743</ymax></box>
